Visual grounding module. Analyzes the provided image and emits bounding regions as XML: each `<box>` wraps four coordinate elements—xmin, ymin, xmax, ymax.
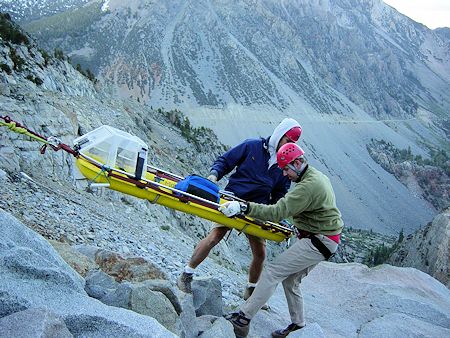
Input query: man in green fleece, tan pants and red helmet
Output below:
<box><xmin>219</xmin><ymin>143</ymin><xmax>344</xmax><ymax>337</ymax></box>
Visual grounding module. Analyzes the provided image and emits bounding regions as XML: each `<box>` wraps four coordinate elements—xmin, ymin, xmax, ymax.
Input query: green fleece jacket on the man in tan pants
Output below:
<box><xmin>247</xmin><ymin>165</ymin><xmax>344</xmax><ymax>235</ymax></box>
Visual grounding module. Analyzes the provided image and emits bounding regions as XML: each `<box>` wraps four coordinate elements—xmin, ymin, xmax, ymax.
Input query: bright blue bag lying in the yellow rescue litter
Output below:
<box><xmin>175</xmin><ymin>175</ymin><xmax>220</xmax><ymax>203</ymax></box>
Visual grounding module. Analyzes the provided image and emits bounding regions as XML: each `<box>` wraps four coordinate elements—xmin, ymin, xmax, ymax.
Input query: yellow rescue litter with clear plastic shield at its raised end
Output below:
<box><xmin>74</xmin><ymin>126</ymin><xmax>293</xmax><ymax>242</ymax></box>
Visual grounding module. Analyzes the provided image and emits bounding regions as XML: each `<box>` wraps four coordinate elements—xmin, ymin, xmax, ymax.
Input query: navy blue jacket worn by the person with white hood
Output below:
<box><xmin>211</xmin><ymin>138</ymin><xmax>290</xmax><ymax>204</ymax></box>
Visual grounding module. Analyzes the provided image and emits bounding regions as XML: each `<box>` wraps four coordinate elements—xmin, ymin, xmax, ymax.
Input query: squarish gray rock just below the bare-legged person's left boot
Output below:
<box><xmin>192</xmin><ymin>278</ymin><xmax>223</xmax><ymax>317</ymax></box>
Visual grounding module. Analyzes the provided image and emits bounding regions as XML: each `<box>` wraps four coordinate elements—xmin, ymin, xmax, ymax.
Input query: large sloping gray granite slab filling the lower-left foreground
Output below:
<box><xmin>0</xmin><ymin>210</ymin><xmax>174</xmax><ymax>337</ymax></box>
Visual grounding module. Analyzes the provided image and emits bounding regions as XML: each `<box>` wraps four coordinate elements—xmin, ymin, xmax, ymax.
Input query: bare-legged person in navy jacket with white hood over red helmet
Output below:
<box><xmin>177</xmin><ymin>118</ymin><xmax>302</xmax><ymax>300</ymax></box>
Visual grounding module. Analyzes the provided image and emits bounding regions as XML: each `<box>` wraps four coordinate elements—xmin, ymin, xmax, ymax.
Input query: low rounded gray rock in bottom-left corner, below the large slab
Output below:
<box><xmin>0</xmin><ymin>308</ymin><xmax>73</xmax><ymax>338</ymax></box>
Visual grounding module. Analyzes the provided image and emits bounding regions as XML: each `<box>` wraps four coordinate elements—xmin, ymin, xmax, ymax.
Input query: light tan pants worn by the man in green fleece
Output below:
<box><xmin>240</xmin><ymin>235</ymin><xmax>338</xmax><ymax>326</ymax></box>
